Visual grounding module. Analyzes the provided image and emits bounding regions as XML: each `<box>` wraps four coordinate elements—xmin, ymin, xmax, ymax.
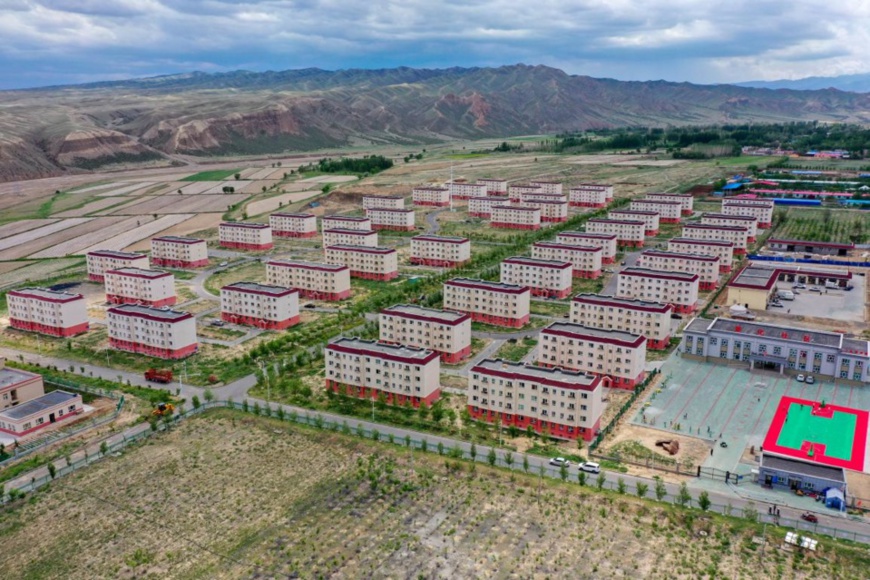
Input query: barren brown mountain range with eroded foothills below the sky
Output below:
<box><xmin>0</xmin><ymin>65</ymin><xmax>870</xmax><ymax>181</ymax></box>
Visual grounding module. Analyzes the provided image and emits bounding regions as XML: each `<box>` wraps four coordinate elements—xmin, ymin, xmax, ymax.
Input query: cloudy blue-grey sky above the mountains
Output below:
<box><xmin>0</xmin><ymin>0</ymin><xmax>870</xmax><ymax>88</ymax></box>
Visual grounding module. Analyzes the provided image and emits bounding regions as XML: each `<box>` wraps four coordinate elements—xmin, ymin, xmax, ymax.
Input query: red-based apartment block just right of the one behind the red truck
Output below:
<box><xmin>221</xmin><ymin>282</ymin><xmax>299</xmax><ymax>330</ymax></box>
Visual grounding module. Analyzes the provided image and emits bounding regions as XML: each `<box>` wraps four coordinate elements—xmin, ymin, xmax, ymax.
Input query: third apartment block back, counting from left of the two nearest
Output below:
<box><xmin>443</xmin><ymin>278</ymin><xmax>531</xmax><ymax>328</ymax></box>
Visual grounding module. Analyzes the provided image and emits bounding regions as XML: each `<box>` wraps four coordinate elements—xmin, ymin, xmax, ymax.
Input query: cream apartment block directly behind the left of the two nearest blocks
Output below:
<box><xmin>378</xmin><ymin>304</ymin><xmax>471</xmax><ymax>364</ymax></box>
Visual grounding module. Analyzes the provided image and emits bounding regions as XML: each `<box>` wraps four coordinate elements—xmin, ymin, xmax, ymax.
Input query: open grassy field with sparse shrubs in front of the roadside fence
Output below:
<box><xmin>0</xmin><ymin>412</ymin><xmax>870</xmax><ymax>578</ymax></box>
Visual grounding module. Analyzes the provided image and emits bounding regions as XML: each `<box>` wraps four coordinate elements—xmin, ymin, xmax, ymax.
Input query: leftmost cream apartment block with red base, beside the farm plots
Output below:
<box><xmin>6</xmin><ymin>288</ymin><xmax>88</xmax><ymax>337</ymax></box>
